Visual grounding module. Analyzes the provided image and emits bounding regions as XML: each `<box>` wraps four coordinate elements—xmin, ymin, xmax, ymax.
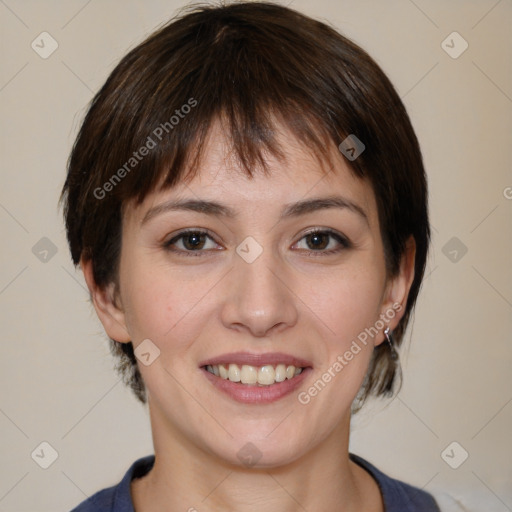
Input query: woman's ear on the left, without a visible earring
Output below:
<box><xmin>80</xmin><ymin>259</ymin><xmax>131</xmax><ymax>343</ymax></box>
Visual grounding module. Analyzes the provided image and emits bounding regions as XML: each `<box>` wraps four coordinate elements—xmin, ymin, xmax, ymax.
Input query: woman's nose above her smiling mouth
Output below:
<box><xmin>221</xmin><ymin>251</ymin><xmax>298</xmax><ymax>337</ymax></box>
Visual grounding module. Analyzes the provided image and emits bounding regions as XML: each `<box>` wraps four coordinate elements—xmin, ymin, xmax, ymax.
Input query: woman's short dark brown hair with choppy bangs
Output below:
<box><xmin>61</xmin><ymin>2</ymin><xmax>430</xmax><ymax>408</ymax></box>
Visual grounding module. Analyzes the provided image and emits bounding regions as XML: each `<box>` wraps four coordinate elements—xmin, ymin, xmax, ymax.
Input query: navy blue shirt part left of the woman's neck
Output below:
<box><xmin>71</xmin><ymin>455</ymin><xmax>155</xmax><ymax>512</ymax></box>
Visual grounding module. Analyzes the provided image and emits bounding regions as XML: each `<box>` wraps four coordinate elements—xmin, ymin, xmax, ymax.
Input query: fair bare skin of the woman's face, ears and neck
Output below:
<box><xmin>82</xmin><ymin>125</ymin><xmax>414</xmax><ymax>512</ymax></box>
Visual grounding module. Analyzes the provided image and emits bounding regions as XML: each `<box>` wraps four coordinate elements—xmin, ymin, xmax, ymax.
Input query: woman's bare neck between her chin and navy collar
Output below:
<box><xmin>131</xmin><ymin>407</ymin><xmax>381</xmax><ymax>512</ymax></box>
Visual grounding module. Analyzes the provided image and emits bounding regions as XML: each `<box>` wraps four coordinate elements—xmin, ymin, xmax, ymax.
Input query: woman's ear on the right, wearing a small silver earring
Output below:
<box><xmin>376</xmin><ymin>236</ymin><xmax>416</xmax><ymax>345</ymax></box>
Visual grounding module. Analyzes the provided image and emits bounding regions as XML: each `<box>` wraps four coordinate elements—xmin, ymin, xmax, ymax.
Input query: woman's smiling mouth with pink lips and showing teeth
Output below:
<box><xmin>200</xmin><ymin>352</ymin><xmax>312</xmax><ymax>404</ymax></box>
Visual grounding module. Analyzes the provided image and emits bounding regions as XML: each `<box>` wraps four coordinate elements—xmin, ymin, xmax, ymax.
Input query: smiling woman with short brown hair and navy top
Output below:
<box><xmin>63</xmin><ymin>2</ymin><xmax>439</xmax><ymax>512</ymax></box>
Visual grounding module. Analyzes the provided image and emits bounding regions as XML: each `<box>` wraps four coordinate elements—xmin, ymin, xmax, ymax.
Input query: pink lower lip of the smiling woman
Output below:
<box><xmin>201</xmin><ymin>368</ymin><xmax>311</xmax><ymax>404</ymax></box>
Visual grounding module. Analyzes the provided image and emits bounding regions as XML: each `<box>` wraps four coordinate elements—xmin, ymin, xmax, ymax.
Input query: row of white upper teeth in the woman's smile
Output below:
<box><xmin>206</xmin><ymin>363</ymin><xmax>303</xmax><ymax>386</ymax></box>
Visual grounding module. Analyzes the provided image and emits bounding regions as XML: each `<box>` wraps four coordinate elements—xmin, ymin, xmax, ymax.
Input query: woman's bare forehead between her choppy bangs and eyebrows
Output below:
<box><xmin>126</xmin><ymin>122</ymin><xmax>378</xmax><ymax>224</ymax></box>
